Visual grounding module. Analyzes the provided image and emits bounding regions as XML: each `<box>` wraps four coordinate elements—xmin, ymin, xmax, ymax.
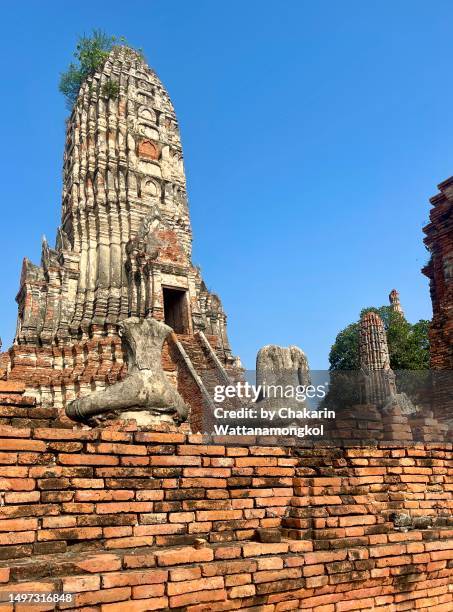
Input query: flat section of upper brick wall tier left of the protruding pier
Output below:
<box><xmin>0</xmin><ymin>426</ymin><xmax>298</xmax><ymax>558</ymax></box>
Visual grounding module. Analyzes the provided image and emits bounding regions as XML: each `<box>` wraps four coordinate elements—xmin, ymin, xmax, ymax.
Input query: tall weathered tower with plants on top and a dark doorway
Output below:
<box><xmin>2</xmin><ymin>47</ymin><xmax>237</xmax><ymax>426</ymax></box>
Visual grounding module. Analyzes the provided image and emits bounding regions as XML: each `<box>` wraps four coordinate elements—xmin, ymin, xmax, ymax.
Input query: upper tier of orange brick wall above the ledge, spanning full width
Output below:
<box><xmin>0</xmin><ymin>426</ymin><xmax>453</xmax><ymax>558</ymax></box>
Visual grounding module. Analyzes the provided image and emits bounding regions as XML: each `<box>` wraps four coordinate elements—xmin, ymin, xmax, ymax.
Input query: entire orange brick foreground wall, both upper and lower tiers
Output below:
<box><xmin>0</xmin><ymin>416</ymin><xmax>453</xmax><ymax>612</ymax></box>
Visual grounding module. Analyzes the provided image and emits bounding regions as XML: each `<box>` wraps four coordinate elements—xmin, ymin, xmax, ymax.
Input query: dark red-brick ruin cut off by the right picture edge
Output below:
<box><xmin>422</xmin><ymin>177</ymin><xmax>453</xmax><ymax>424</ymax></box>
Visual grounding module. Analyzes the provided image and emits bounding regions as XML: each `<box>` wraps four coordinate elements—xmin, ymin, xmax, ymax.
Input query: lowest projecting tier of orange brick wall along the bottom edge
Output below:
<box><xmin>0</xmin><ymin>532</ymin><xmax>453</xmax><ymax>612</ymax></box>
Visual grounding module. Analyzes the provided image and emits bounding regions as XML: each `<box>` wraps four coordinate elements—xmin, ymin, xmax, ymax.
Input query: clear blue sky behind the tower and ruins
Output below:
<box><xmin>0</xmin><ymin>0</ymin><xmax>453</xmax><ymax>368</ymax></box>
